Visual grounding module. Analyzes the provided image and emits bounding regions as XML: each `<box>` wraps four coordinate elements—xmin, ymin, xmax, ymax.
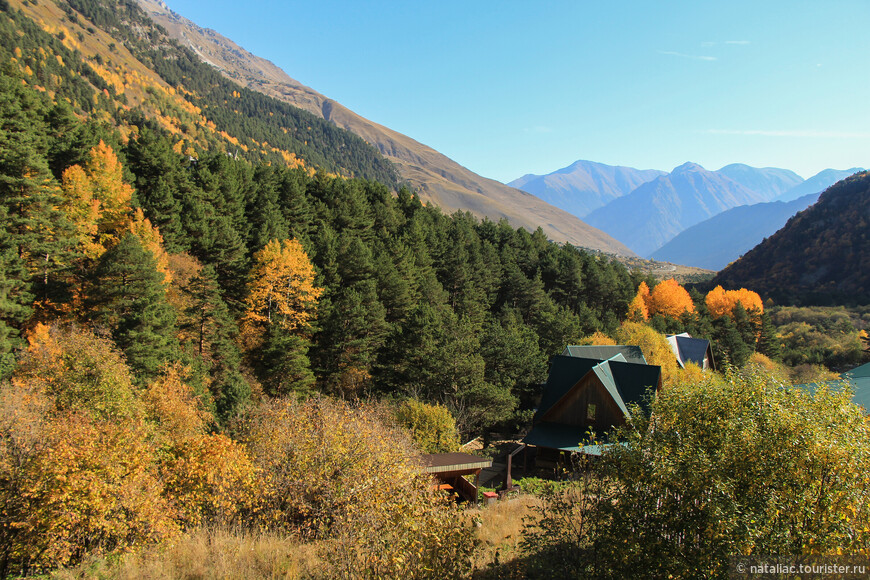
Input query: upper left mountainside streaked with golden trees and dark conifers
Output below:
<box><xmin>7</xmin><ymin>0</ymin><xmax>397</xmax><ymax>186</ymax></box>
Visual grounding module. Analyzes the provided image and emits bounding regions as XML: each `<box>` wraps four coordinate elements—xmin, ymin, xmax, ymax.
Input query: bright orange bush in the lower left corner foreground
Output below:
<box><xmin>18</xmin><ymin>413</ymin><xmax>177</xmax><ymax>568</ymax></box>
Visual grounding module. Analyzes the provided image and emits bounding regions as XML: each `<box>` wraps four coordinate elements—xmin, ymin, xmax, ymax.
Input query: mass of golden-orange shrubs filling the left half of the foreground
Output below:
<box><xmin>0</xmin><ymin>328</ymin><xmax>474</xmax><ymax>578</ymax></box>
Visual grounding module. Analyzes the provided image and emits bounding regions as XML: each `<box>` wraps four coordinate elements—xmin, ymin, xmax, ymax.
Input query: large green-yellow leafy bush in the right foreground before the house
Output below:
<box><xmin>524</xmin><ymin>373</ymin><xmax>870</xmax><ymax>578</ymax></box>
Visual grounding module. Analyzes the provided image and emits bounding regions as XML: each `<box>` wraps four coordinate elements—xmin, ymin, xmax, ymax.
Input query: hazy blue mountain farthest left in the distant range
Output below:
<box><xmin>508</xmin><ymin>160</ymin><xmax>665</xmax><ymax>218</ymax></box>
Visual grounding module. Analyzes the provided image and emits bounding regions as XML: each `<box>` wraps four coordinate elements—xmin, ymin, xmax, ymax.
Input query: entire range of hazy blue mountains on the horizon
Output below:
<box><xmin>510</xmin><ymin>160</ymin><xmax>860</xmax><ymax>260</ymax></box>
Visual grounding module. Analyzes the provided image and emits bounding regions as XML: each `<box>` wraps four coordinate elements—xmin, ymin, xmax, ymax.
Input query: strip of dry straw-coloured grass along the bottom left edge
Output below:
<box><xmin>52</xmin><ymin>529</ymin><xmax>322</xmax><ymax>580</ymax></box>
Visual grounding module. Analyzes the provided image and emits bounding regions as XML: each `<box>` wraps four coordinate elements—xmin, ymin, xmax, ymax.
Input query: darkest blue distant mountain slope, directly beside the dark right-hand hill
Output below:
<box><xmin>651</xmin><ymin>193</ymin><xmax>820</xmax><ymax>270</ymax></box>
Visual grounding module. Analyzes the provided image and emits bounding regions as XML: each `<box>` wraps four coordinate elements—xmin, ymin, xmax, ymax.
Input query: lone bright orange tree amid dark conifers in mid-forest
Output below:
<box><xmin>244</xmin><ymin>239</ymin><xmax>323</xmax><ymax>330</ymax></box>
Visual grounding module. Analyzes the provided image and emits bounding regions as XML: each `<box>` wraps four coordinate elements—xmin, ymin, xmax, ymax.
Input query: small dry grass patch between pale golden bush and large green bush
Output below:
<box><xmin>468</xmin><ymin>495</ymin><xmax>541</xmax><ymax>570</ymax></box>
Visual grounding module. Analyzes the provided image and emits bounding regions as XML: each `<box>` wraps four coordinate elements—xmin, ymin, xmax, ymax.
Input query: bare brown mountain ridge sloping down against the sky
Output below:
<box><xmin>131</xmin><ymin>0</ymin><xmax>632</xmax><ymax>255</ymax></box>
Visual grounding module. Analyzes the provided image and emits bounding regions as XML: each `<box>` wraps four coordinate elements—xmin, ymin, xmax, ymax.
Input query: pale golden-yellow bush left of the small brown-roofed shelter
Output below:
<box><xmin>240</xmin><ymin>399</ymin><xmax>474</xmax><ymax>578</ymax></box>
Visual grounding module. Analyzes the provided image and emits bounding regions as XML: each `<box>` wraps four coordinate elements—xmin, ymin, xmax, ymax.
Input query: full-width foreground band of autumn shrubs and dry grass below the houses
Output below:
<box><xmin>0</xmin><ymin>327</ymin><xmax>870</xmax><ymax>578</ymax></box>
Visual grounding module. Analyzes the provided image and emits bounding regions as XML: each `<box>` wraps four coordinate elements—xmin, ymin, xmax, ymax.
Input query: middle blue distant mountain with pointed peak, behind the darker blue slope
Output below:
<box><xmin>586</xmin><ymin>163</ymin><xmax>766</xmax><ymax>256</ymax></box>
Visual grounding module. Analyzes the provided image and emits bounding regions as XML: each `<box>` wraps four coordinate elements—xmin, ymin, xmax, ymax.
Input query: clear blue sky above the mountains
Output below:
<box><xmin>166</xmin><ymin>0</ymin><xmax>870</xmax><ymax>181</ymax></box>
